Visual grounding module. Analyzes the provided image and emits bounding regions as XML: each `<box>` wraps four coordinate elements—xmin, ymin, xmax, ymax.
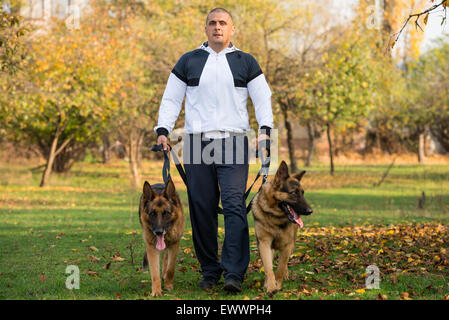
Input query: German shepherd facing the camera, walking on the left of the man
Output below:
<box><xmin>139</xmin><ymin>178</ymin><xmax>184</xmax><ymax>297</ymax></box>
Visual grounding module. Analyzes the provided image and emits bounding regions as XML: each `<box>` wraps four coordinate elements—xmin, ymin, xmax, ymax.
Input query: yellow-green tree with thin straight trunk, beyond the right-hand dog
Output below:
<box><xmin>304</xmin><ymin>26</ymin><xmax>376</xmax><ymax>175</ymax></box>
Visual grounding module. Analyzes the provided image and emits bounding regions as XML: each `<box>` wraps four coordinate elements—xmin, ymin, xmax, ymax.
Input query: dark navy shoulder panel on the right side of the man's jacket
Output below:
<box><xmin>226</xmin><ymin>50</ymin><xmax>262</xmax><ymax>87</ymax></box>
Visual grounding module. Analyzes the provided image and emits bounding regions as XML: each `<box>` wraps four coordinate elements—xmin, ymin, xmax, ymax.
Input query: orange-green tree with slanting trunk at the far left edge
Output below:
<box><xmin>1</xmin><ymin>15</ymin><xmax>115</xmax><ymax>186</ymax></box>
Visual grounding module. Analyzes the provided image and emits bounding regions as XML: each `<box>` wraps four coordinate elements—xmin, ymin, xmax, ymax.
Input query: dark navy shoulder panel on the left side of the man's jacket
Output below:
<box><xmin>172</xmin><ymin>49</ymin><xmax>209</xmax><ymax>86</ymax></box>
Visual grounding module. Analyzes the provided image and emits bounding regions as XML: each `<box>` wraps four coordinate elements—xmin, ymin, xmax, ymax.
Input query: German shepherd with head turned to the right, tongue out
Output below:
<box><xmin>252</xmin><ymin>161</ymin><xmax>313</xmax><ymax>294</ymax></box>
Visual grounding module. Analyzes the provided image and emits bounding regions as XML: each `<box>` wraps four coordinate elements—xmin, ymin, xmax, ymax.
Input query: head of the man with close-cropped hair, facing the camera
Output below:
<box><xmin>205</xmin><ymin>12</ymin><xmax>235</xmax><ymax>45</ymax></box>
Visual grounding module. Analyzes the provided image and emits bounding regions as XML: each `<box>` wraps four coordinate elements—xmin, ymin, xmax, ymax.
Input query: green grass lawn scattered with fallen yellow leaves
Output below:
<box><xmin>0</xmin><ymin>162</ymin><xmax>449</xmax><ymax>300</ymax></box>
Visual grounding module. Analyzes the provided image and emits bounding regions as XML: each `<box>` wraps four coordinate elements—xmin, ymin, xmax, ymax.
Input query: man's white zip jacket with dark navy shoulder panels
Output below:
<box><xmin>154</xmin><ymin>42</ymin><xmax>273</xmax><ymax>135</ymax></box>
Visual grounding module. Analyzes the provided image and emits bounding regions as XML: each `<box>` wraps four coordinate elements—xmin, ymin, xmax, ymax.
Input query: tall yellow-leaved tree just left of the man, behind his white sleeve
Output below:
<box><xmin>94</xmin><ymin>1</ymin><xmax>204</xmax><ymax>188</ymax></box>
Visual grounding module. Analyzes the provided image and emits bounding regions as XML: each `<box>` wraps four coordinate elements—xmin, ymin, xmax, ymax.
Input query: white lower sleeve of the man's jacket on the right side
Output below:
<box><xmin>248</xmin><ymin>73</ymin><xmax>273</xmax><ymax>128</ymax></box>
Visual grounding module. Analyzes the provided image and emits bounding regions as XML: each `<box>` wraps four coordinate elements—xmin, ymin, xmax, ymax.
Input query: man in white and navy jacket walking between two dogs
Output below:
<box><xmin>154</xmin><ymin>8</ymin><xmax>273</xmax><ymax>292</ymax></box>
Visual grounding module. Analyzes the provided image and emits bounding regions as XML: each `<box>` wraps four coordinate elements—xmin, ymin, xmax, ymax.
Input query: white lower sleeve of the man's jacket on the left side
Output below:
<box><xmin>154</xmin><ymin>72</ymin><xmax>187</xmax><ymax>133</ymax></box>
